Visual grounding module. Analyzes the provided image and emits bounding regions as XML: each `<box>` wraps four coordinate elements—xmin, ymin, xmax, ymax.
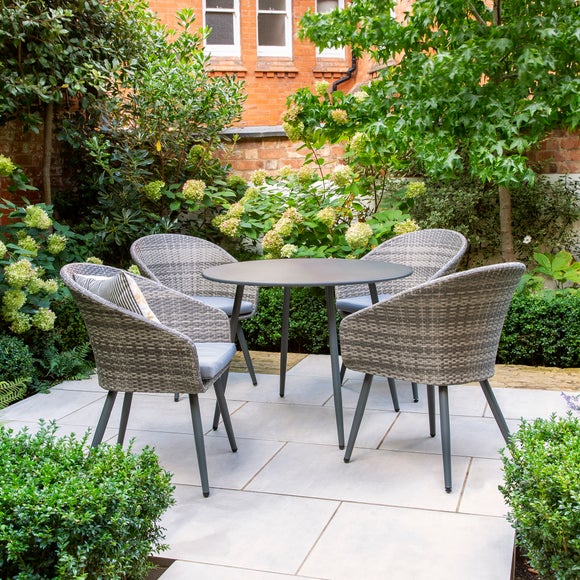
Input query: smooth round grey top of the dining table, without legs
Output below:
<box><xmin>203</xmin><ymin>258</ymin><xmax>413</xmax><ymax>287</ymax></box>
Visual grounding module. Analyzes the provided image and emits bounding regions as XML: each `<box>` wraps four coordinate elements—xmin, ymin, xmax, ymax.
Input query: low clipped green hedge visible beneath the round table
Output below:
<box><xmin>243</xmin><ymin>288</ymin><xmax>336</xmax><ymax>354</ymax></box>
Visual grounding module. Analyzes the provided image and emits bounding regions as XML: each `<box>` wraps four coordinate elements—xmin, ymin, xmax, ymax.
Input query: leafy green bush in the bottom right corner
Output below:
<box><xmin>500</xmin><ymin>413</ymin><xmax>580</xmax><ymax>580</ymax></box>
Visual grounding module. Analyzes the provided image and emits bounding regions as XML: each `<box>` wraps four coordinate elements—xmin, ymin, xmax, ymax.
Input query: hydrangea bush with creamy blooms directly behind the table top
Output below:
<box><xmin>213</xmin><ymin>165</ymin><xmax>417</xmax><ymax>258</ymax></box>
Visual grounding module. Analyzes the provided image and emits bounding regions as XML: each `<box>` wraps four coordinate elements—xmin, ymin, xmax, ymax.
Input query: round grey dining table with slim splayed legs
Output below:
<box><xmin>202</xmin><ymin>258</ymin><xmax>413</xmax><ymax>449</ymax></box>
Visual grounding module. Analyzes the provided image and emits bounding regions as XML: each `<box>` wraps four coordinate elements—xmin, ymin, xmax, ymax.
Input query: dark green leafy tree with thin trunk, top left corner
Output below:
<box><xmin>0</xmin><ymin>0</ymin><xmax>152</xmax><ymax>204</ymax></box>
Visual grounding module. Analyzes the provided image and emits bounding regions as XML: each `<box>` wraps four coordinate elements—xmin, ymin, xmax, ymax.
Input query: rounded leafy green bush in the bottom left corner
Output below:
<box><xmin>0</xmin><ymin>424</ymin><xmax>173</xmax><ymax>580</ymax></box>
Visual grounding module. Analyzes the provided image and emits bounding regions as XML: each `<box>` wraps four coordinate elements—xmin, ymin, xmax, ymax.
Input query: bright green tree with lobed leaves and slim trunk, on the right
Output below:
<box><xmin>286</xmin><ymin>0</ymin><xmax>580</xmax><ymax>260</ymax></box>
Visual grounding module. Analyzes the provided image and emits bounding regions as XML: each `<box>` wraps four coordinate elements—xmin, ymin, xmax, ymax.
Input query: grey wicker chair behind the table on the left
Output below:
<box><xmin>131</xmin><ymin>234</ymin><xmax>258</xmax><ymax>385</ymax></box>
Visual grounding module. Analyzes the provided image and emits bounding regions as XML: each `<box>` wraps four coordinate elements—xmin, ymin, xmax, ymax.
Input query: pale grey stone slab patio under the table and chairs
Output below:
<box><xmin>0</xmin><ymin>355</ymin><xmax>566</xmax><ymax>580</ymax></box>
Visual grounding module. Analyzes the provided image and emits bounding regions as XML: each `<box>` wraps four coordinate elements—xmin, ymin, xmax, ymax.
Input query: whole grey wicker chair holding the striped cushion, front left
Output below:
<box><xmin>60</xmin><ymin>263</ymin><xmax>237</xmax><ymax>497</ymax></box>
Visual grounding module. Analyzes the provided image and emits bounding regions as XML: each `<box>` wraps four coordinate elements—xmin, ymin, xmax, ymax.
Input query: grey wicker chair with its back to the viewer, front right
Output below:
<box><xmin>340</xmin><ymin>262</ymin><xmax>525</xmax><ymax>492</ymax></box>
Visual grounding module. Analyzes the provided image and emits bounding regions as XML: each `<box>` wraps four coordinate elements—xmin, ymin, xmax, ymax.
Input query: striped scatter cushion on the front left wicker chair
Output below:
<box><xmin>75</xmin><ymin>272</ymin><xmax>159</xmax><ymax>322</ymax></box>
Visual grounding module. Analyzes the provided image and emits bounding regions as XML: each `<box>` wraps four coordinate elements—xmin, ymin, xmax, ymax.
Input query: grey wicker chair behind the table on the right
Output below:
<box><xmin>336</xmin><ymin>229</ymin><xmax>467</xmax><ymax>411</ymax></box>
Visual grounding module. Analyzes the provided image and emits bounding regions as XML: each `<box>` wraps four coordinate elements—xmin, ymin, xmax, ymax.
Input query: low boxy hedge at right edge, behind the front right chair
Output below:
<box><xmin>497</xmin><ymin>293</ymin><xmax>580</xmax><ymax>368</ymax></box>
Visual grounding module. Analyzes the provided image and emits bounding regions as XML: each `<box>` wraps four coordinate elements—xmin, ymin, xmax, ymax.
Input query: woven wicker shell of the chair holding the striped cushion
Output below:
<box><xmin>61</xmin><ymin>263</ymin><xmax>231</xmax><ymax>393</ymax></box>
